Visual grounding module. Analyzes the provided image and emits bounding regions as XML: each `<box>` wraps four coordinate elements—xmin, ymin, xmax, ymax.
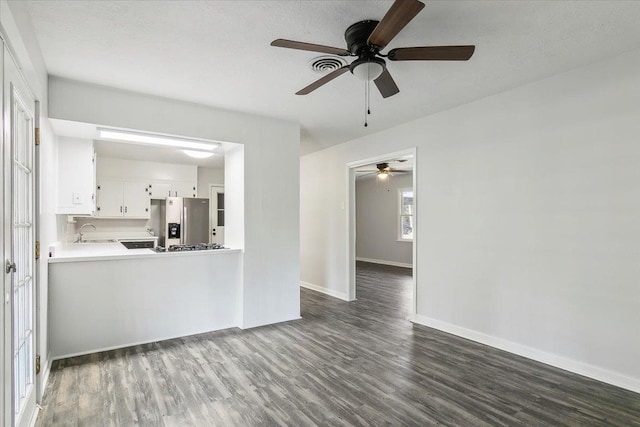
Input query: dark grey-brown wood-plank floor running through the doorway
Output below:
<box><xmin>37</xmin><ymin>263</ymin><xmax>640</xmax><ymax>427</ymax></box>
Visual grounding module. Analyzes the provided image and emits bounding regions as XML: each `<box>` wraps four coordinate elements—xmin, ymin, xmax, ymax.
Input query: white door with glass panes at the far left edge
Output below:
<box><xmin>3</xmin><ymin>49</ymin><xmax>36</xmax><ymax>427</ymax></box>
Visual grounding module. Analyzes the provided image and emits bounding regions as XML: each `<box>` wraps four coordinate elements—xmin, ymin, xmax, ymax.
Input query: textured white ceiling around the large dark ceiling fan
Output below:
<box><xmin>26</xmin><ymin>0</ymin><xmax>640</xmax><ymax>153</ymax></box>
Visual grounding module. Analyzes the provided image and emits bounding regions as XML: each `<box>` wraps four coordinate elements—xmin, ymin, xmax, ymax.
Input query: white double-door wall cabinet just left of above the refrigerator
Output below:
<box><xmin>96</xmin><ymin>180</ymin><xmax>150</xmax><ymax>219</ymax></box>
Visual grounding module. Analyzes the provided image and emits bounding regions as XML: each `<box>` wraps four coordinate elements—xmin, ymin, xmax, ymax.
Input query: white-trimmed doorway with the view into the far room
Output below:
<box><xmin>347</xmin><ymin>148</ymin><xmax>418</xmax><ymax>320</ymax></box>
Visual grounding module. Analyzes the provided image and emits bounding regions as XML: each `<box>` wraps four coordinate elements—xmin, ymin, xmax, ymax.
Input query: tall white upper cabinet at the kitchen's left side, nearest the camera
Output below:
<box><xmin>56</xmin><ymin>137</ymin><xmax>96</xmax><ymax>216</ymax></box>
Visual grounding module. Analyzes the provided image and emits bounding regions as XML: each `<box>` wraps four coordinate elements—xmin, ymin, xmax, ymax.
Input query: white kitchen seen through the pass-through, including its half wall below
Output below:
<box><xmin>46</xmin><ymin>127</ymin><xmax>242</xmax><ymax>360</ymax></box>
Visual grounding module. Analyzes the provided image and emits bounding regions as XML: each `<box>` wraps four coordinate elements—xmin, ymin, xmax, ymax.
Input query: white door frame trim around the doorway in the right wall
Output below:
<box><xmin>346</xmin><ymin>147</ymin><xmax>419</xmax><ymax>321</ymax></box>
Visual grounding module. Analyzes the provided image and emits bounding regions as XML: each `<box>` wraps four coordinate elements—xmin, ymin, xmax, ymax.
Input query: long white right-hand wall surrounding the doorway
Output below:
<box><xmin>300</xmin><ymin>50</ymin><xmax>640</xmax><ymax>391</ymax></box>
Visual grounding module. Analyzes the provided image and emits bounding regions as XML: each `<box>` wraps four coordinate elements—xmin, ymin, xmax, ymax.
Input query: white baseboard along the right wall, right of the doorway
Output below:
<box><xmin>413</xmin><ymin>314</ymin><xmax>640</xmax><ymax>393</ymax></box>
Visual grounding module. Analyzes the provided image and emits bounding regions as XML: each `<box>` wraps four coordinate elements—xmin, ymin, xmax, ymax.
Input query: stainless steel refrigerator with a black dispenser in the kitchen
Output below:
<box><xmin>158</xmin><ymin>197</ymin><xmax>209</xmax><ymax>248</ymax></box>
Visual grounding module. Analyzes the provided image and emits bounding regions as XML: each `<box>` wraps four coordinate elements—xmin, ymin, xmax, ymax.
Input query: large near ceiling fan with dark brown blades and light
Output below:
<box><xmin>271</xmin><ymin>0</ymin><xmax>475</xmax><ymax>98</ymax></box>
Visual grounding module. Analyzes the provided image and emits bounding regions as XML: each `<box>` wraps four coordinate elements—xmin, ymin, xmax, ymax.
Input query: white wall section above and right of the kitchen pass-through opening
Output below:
<box><xmin>49</xmin><ymin>77</ymin><xmax>300</xmax><ymax>327</ymax></box>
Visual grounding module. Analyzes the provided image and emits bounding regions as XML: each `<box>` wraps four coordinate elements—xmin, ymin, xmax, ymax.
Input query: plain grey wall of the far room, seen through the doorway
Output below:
<box><xmin>356</xmin><ymin>173</ymin><xmax>413</xmax><ymax>266</ymax></box>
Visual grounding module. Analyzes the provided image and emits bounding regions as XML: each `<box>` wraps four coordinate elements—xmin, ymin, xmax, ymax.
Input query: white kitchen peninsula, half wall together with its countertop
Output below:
<box><xmin>48</xmin><ymin>242</ymin><xmax>243</xmax><ymax>359</ymax></box>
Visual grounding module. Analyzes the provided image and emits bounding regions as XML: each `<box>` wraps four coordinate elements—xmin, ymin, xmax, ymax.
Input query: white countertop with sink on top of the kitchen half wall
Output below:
<box><xmin>48</xmin><ymin>242</ymin><xmax>241</xmax><ymax>263</ymax></box>
